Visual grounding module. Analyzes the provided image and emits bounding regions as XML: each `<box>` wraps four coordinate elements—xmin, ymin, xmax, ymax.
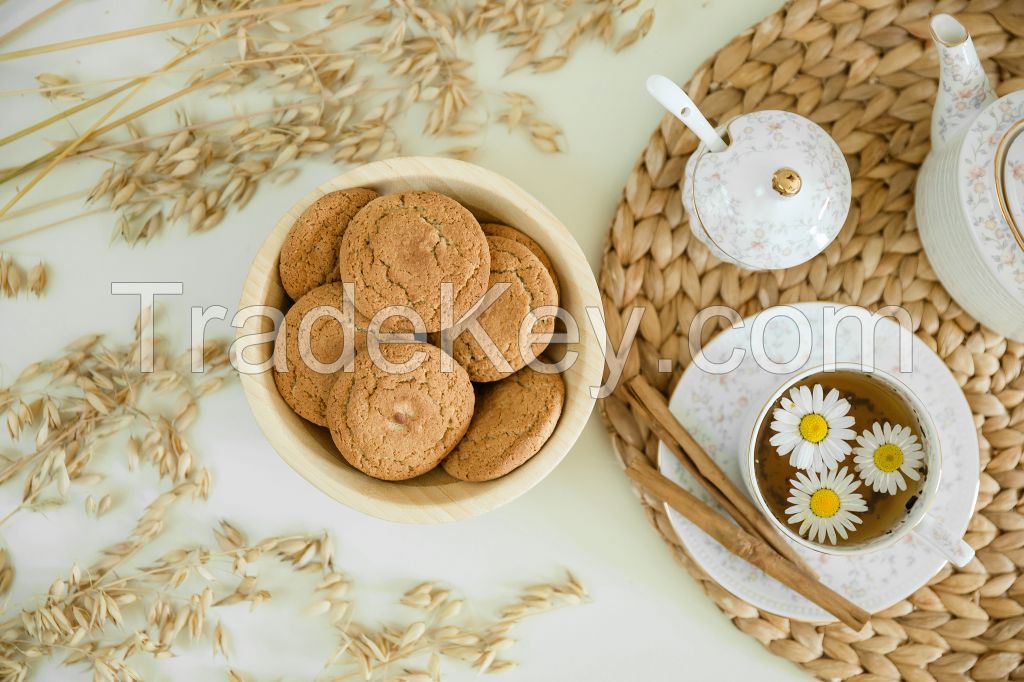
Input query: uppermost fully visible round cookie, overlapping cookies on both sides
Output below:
<box><xmin>340</xmin><ymin>191</ymin><xmax>490</xmax><ymax>332</ymax></box>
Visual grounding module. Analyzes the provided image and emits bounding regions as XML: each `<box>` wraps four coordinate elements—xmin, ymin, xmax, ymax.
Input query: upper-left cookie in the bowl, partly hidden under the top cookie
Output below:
<box><xmin>278</xmin><ymin>187</ymin><xmax>380</xmax><ymax>301</ymax></box>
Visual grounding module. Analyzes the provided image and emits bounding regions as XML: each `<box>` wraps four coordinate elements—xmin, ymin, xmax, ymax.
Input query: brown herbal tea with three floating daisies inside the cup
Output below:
<box><xmin>754</xmin><ymin>371</ymin><xmax>928</xmax><ymax>545</ymax></box>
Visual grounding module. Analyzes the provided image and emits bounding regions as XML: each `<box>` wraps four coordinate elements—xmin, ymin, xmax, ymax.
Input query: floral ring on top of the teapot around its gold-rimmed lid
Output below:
<box><xmin>957</xmin><ymin>91</ymin><xmax>1024</xmax><ymax>301</ymax></box>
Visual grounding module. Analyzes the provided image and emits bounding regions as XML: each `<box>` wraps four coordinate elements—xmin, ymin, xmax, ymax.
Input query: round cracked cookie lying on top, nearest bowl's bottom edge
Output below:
<box><xmin>328</xmin><ymin>343</ymin><xmax>475</xmax><ymax>480</ymax></box>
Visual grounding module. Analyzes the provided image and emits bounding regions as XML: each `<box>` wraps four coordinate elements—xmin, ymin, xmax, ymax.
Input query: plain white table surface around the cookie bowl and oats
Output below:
<box><xmin>0</xmin><ymin>0</ymin><xmax>803</xmax><ymax>682</ymax></box>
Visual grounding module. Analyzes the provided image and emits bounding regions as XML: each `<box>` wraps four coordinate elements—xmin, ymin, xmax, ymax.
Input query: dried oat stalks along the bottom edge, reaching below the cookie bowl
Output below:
<box><xmin>0</xmin><ymin>481</ymin><xmax>587</xmax><ymax>682</ymax></box>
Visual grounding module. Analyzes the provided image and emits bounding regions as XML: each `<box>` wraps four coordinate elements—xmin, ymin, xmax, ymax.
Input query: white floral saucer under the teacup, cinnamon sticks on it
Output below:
<box><xmin>658</xmin><ymin>302</ymin><xmax>979</xmax><ymax>623</ymax></box>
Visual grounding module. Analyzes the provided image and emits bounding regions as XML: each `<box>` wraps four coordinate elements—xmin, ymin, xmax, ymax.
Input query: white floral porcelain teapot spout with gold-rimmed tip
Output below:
<box><xmin>931</xmin><ymin>14</ymin><xmax>995</xmax><ymax>148</ymax></box>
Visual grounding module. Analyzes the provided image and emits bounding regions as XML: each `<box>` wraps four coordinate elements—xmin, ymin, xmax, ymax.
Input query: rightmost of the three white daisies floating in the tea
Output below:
<box><xmin>853</xmin><ymin>422</ymin><xmax>925</xmax><ymax>495</ymax></box>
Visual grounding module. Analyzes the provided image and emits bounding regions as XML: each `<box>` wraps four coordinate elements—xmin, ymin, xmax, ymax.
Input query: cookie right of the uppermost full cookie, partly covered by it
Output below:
<box><xmin>452</xmin><ymin>237</ymin><xmax>558</xmax><ymax>381</ymax></box>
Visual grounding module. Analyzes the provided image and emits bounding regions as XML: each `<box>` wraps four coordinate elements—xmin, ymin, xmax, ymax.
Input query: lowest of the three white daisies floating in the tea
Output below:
<box><xmin>785</xmin><ymin>467</ymin><xmax>867</xmax><ymax>545</ymax></box>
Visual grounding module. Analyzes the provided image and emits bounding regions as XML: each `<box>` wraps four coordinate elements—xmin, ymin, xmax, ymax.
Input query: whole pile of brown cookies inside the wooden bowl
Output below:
<box><xmin>274</xmin><ymin>188</ymin><xmax>565</xmax><ymax>481</ymax></box>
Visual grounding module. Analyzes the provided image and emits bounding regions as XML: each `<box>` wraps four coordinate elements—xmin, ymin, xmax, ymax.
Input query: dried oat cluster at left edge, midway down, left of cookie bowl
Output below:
<box><xmin>0</xmin><ymin>311</ymin><xmax>230</xmax><ymax>523</ymax></box>
